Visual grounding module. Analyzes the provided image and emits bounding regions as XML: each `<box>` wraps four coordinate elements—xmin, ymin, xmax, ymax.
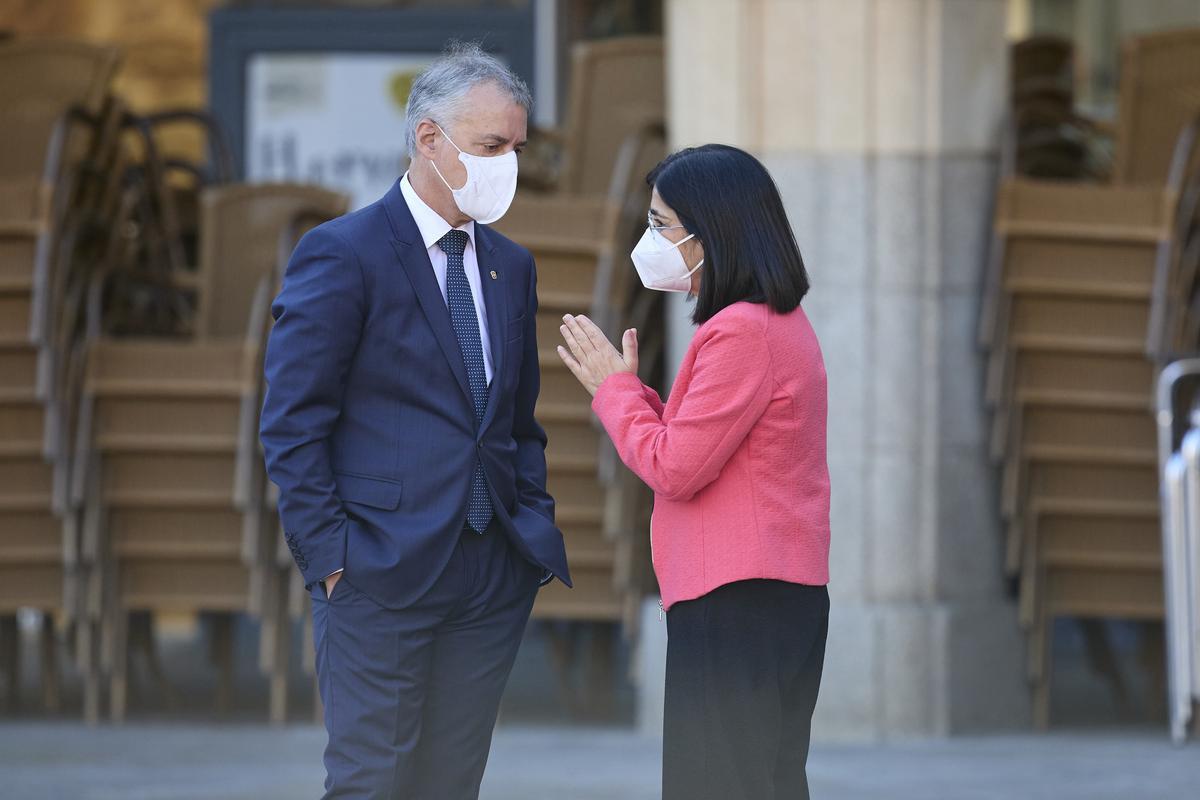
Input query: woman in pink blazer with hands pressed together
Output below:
<box><xmin>558</xmin><ymin>145</ymin><xmax>829</xmax><ymax>800</ymax></box>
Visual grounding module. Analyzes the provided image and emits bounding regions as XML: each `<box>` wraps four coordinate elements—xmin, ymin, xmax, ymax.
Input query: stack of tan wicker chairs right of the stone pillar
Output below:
<box><xmin>979</xmin><ymin>31</ymin><xmax>1200</xmax><ymax>727</ymax></box>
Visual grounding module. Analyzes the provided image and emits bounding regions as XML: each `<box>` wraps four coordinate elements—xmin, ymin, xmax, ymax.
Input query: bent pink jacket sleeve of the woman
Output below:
<box><xmin>592</xmin><ymin>325</ymin><xmax>774</xmax><ymax>500</ymax></box>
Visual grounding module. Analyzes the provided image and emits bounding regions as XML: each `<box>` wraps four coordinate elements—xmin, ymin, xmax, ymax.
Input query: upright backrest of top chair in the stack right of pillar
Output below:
<box><xmin>1112</xmin><ymin>29</ymin><xmax>1200</xmax><ymax>185</ymax></box>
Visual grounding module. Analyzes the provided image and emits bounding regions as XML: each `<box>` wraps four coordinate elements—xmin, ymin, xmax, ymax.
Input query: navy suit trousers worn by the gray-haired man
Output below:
<box><xmin>312</xmin><ymin>521</ymin><xmax>541</xmax><ymax>800</ymax></box>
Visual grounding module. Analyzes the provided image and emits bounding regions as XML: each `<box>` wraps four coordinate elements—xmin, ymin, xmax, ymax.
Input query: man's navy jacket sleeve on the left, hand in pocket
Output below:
<box><xmin>259</xmin><ymin>228</ymin><xmax>366</xmax><ymax>585</ymax></box>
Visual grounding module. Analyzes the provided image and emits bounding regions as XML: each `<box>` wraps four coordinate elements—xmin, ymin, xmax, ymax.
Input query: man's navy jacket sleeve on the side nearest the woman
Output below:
<box><xmin>512</xmin><ymin>251</ymin><xmax>554</xmax><ymax>523</ymax></box>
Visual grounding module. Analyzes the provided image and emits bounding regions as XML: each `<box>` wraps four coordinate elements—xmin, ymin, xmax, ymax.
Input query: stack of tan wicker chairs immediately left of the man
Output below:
<box><xmin>72</xmin><ymin>185</ymin><xmax>347</xmax><ymax>720</ymax></box>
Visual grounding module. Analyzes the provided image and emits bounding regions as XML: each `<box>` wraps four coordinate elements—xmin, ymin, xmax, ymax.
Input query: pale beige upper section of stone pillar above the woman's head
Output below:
<box><xmin>666</xmin><ymin>0</ymin><xmax>1007</xmax><ymax>155</ymax></box>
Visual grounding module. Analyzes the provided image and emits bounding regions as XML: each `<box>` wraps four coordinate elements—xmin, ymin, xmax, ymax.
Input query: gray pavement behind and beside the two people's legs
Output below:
<box><xmin>0</xmin><ymin>722</ymin><xmax>1200</xmax><ymax>800</ymax></box>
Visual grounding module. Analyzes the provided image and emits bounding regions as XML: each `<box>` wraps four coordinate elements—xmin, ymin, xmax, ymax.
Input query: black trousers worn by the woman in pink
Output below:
<box><xmin>662</xmin><ymin>581</ymin><xmax>829</xmax><ymax>800</ymax></box>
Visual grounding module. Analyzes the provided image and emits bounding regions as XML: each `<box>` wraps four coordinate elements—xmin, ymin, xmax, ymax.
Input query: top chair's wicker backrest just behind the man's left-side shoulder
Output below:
<box><xmin>196</xmin><ymin>184</ymin><xmax>349</xmax><ymax>338</ymax></box>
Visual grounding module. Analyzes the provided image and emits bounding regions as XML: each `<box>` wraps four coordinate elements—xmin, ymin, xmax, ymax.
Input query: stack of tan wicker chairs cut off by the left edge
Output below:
<box><xmin>0</xmin><ymin>40</ymin><xmax>118</xmax><ymax>709</ymax></box>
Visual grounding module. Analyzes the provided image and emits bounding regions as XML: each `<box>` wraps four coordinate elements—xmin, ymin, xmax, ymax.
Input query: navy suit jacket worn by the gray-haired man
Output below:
<box><xmin>260</xmin><ymin>181</ymin><xmax>570</xmax><ymax>608</ymax></box>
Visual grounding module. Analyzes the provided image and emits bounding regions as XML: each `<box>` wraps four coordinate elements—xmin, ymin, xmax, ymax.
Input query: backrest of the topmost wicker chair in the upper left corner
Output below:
<box><xmin>0</xmin><ymin>38</ymin><xmax>120</xmax><ymax>218</ymax></box>
